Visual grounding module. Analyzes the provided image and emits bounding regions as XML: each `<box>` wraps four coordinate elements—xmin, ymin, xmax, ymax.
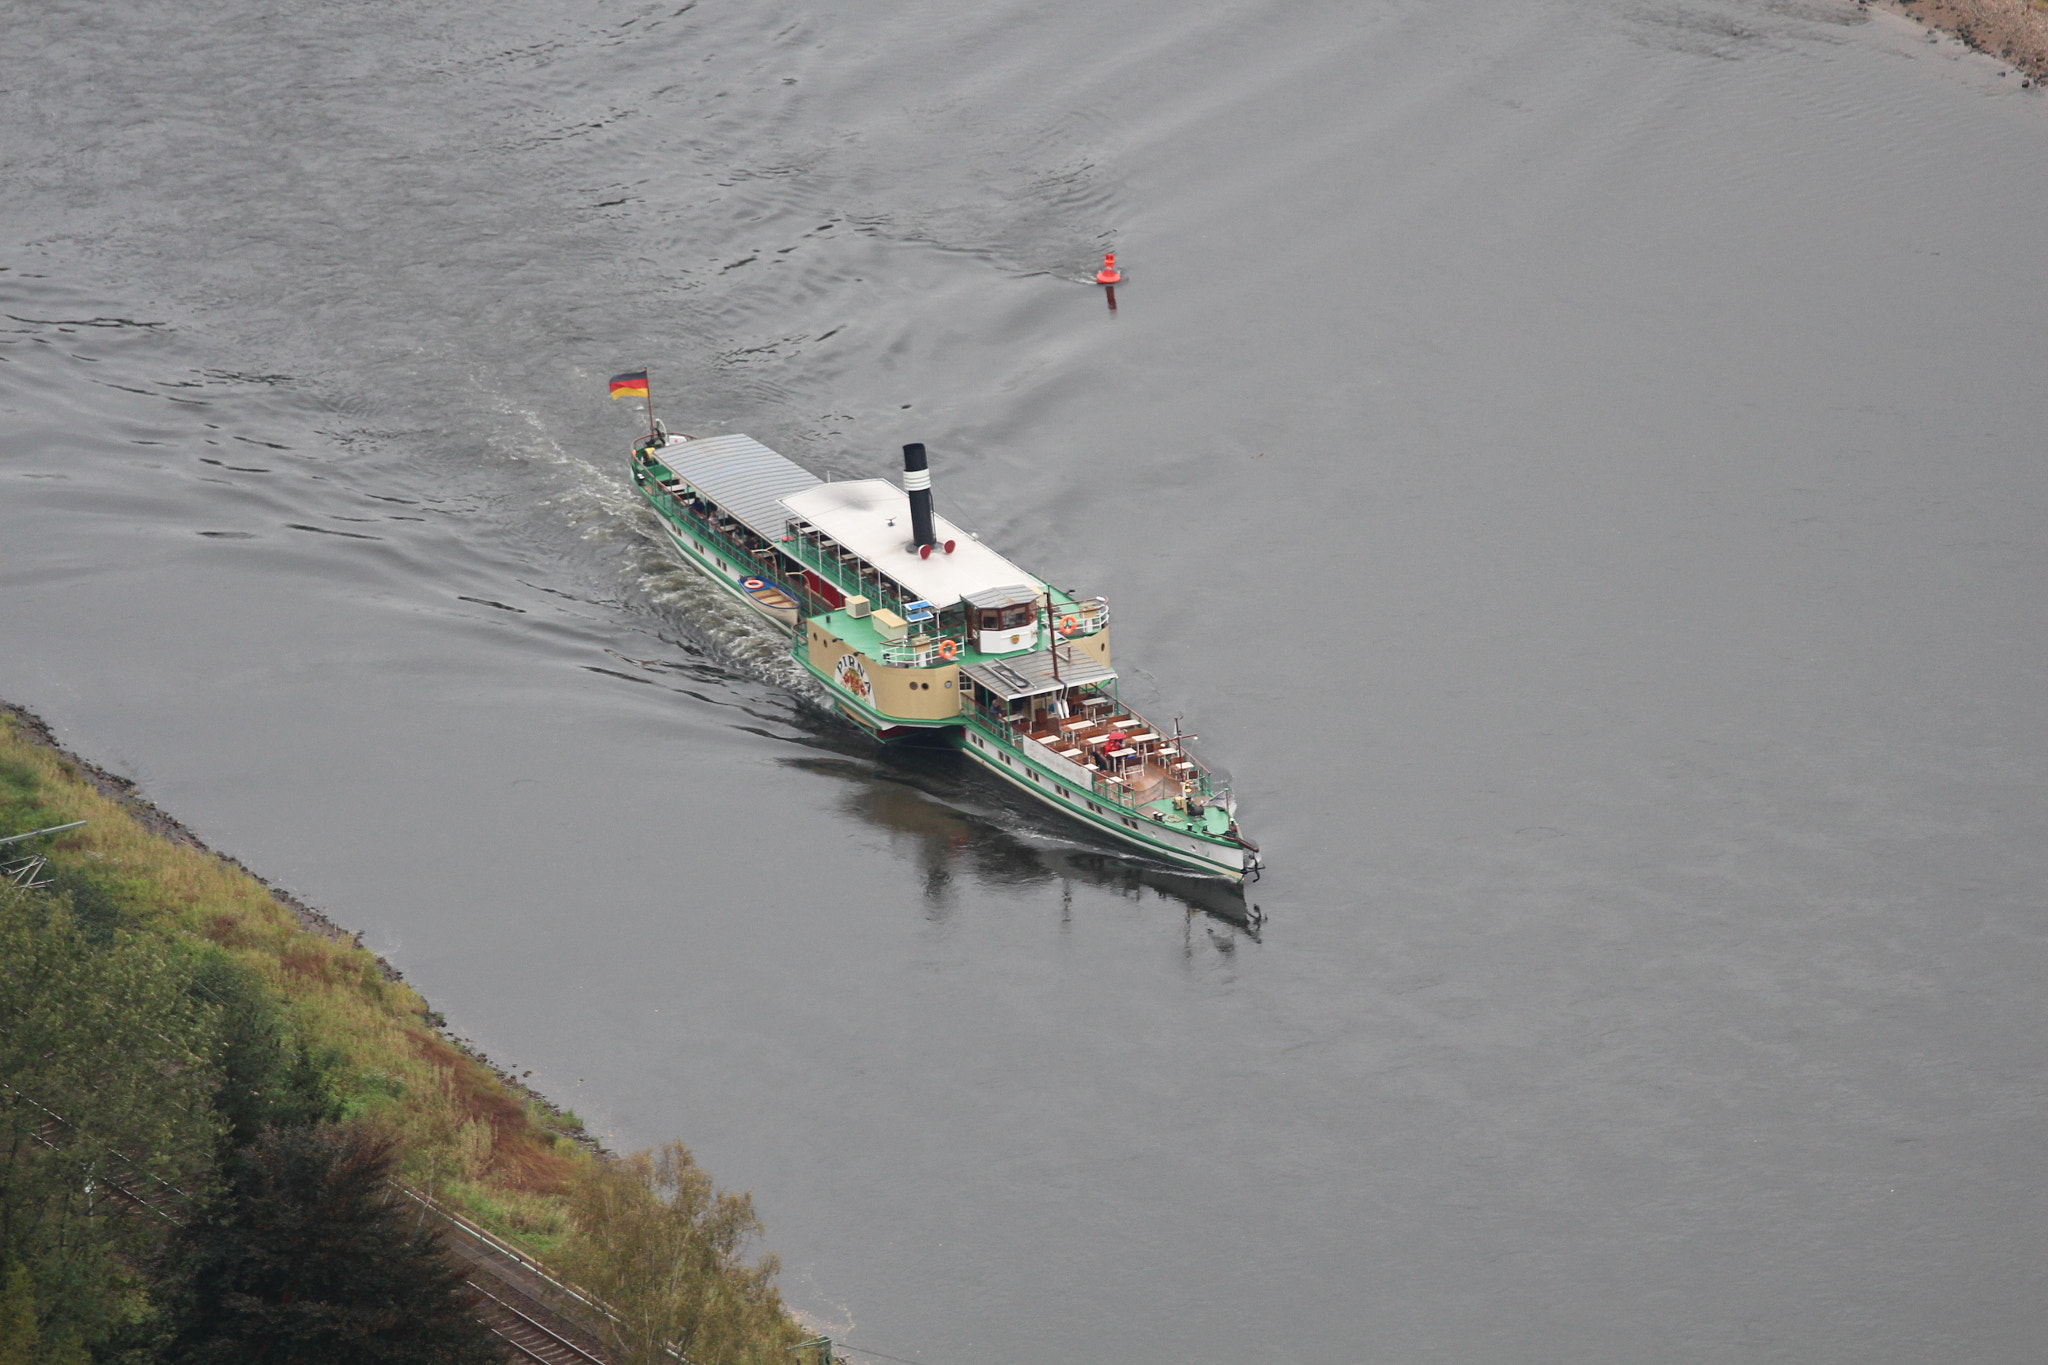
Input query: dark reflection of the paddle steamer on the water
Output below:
<box><xmin>782</xmin><ymin>745</ymin><xmax>1264</xmax><ymax>941</ymax></box>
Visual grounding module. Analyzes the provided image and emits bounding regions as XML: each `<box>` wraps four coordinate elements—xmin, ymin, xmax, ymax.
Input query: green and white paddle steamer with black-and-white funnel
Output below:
<box><xmin>614</xmin><ymin>427</ymin><xmax>1260</xmax><ymax>880</ymax></box>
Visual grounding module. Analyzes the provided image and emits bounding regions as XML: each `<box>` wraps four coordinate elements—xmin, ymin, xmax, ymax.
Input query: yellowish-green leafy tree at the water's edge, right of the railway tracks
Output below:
<box><xmin>557</xmin><ymin>1142</ymin><xmax>797</xmax><ymax>1365</ymax></box>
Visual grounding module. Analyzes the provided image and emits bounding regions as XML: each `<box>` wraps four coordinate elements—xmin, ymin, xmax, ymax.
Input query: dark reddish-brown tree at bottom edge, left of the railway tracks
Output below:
<box><xmin>168</xmin><ymin>1124</ymin><xmax>504</xmax><ymax>1365</ymax></box>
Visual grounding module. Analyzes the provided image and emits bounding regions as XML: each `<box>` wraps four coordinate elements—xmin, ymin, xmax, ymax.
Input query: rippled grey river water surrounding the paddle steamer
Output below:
<box><xmin>0</xmin><ymin>0</ymin><xmax>2048</xmax><ymax>1365</ymax></box>
